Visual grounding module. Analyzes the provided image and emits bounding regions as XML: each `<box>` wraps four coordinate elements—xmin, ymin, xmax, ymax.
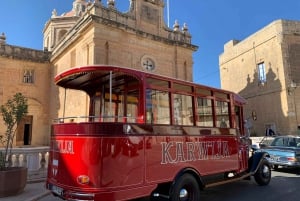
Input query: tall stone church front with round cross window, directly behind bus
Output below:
<box><xmin>44</xmin><ymin>0</ymin><xmax>197</xmax><ymax>121</ymax></box>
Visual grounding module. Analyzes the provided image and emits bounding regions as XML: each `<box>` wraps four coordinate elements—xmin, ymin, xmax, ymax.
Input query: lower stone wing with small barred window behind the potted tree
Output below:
<box><xmin>0</xmin><ymin>34</ymin><xmax>52</xmax><ymax>146</ymax></box>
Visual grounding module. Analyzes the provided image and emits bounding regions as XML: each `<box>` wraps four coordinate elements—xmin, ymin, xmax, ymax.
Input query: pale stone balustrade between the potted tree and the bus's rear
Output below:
<box><xmin>0</xmin><ymin>146</ymin><xmax>49</xmax><ymax>182</ymax></box>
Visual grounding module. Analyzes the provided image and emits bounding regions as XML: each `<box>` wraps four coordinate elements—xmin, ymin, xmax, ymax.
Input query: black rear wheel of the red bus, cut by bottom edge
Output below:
<box><xmin>170</xmin><ymin>174</ymin><xmax>200</xmax><ymax>201</ymax></box>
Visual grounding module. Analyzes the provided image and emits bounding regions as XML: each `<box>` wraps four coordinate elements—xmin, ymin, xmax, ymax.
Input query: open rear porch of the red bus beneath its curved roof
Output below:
<box><xmin>57</xmin><ymin>66</ymin><xmax>141</xmax><ymax>123</ymax></box>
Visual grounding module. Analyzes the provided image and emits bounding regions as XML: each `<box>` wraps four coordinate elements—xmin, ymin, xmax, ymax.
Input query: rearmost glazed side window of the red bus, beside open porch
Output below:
<box><xmin>146</xmin><ymin>89</ymin><xmax>170</xmax><ymax>124</ymax></box>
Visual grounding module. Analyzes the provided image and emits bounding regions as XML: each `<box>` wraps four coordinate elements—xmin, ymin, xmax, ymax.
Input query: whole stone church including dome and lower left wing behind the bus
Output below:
<box><xmin>0</xmin><ymin>0</ymin><xmax>198</xmax><ymax>146</ymax></box>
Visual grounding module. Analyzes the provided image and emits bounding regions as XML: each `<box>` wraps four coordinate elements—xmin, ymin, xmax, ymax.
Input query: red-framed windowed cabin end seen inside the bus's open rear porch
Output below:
<box><xmin>90</xmin><ymin>74</ymin><xmax>140</xmax><ymax>123</ymax></box>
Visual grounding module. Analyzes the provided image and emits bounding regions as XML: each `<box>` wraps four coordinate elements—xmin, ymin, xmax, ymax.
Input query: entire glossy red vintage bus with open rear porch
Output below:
<box><xmin>46</xmin><ymin>66</ymin><xmax>271</xmax><ymax>201</ymax></box>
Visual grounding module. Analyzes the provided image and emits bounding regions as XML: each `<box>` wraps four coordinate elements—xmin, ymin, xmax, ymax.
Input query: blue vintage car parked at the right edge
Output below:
<box><xmin>260</xmin><ymin>136</ymin><xmax>300</xmax><ymax>169</ymax></box>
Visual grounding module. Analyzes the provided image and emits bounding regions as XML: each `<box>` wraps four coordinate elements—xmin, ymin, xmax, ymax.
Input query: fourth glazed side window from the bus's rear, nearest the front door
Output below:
<box><xmin>216</xmin><ymin>101</ymin><xmax>230</xmax><ymax>128</ymax></box>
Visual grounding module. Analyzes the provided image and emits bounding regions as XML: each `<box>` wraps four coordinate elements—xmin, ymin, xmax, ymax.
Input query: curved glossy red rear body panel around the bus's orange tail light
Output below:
<box><xmin>48</xmin><ymin>124</ymin><xmax>144</xmax><ymax>190</ymax></box>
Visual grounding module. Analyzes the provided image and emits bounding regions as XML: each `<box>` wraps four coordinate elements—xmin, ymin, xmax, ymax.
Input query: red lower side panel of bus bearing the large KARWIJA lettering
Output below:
<box><xmin>146</xmin><ymin>133</ymin><xmax>239</xmax><ymax>182</ymax></box>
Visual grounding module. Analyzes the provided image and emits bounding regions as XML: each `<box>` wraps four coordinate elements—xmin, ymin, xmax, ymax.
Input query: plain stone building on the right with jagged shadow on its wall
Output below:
<box><xmin>219</xmin><ymin>20</ymin><xmax>300</xmax><ymax>136</ymax></box>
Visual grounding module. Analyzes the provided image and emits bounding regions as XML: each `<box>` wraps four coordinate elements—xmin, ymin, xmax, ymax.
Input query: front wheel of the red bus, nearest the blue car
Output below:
<box><xmin>254</xmin><ymin>159</ymin><xmax>271</xmax><ymax>186</ymax></box>
